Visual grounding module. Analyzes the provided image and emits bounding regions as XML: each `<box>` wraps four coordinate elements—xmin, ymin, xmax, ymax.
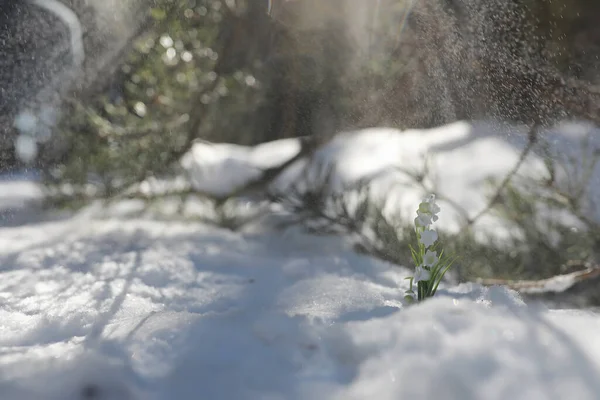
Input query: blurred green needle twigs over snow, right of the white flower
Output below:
<box><xmin>448</xmin><ymin>150</ymin><xmax>600</xmax><ymax>279</ymax></box>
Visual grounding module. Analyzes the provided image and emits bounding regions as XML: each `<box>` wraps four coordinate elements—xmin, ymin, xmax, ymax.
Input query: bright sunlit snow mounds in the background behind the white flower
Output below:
<box><xmin>183</xmin><ymin>122</ymin><xmax>600</xmax><ymax>239</ymax></box>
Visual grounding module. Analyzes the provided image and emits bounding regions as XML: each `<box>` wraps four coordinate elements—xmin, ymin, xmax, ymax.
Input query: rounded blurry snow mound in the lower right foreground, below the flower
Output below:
<box><xmin>317</xmin><ymin>289</ymin><xmax>600</xmax><ymax>400</ymax></box>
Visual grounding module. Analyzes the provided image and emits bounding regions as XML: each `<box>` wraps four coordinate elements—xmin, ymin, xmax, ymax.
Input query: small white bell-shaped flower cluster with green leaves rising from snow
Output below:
<box><xmin>404</xmin><ymin>194</ymin><xmax>453</xmax><ymax>302</ymax></box>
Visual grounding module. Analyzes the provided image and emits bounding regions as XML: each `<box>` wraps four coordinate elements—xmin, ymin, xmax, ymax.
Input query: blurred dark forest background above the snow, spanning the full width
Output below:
<box><xmin>0</xmin><ymin>0</ymin><xmax>600</xmax><ymax>292</ymax></box>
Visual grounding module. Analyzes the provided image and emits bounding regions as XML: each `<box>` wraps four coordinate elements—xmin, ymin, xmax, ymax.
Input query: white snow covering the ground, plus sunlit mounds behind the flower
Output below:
<box><xmin>0</xmin><ymin>123</ymin><xmax>600</xmax><ymax>400</ymax></box>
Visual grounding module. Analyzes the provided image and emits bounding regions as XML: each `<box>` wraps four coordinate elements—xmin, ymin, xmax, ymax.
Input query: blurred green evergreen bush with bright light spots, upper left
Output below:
<box><xmin>48</xmin><ymin>0</ymin><xmax>261</xmax><ymax>196</ymax></box>
